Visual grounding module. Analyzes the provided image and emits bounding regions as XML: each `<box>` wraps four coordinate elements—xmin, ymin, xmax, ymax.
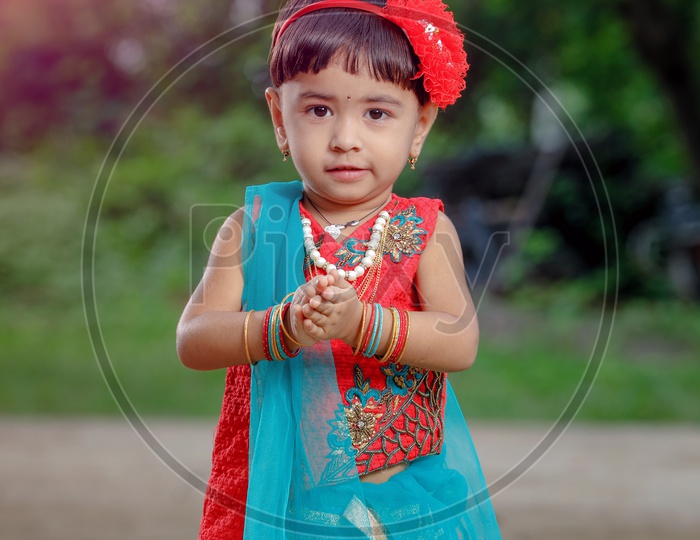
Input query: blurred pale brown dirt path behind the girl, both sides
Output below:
<box><xmin>0</xmin><ymin>418</ymin><xmax>700</xmax><ymax>540</ymax></box>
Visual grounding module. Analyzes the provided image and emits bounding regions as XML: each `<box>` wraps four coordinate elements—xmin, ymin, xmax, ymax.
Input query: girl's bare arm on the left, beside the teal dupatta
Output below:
<box><xmin>177</xmin><ymin>209</ymin><xmax>315</xmax><ymax>370</ymax></box>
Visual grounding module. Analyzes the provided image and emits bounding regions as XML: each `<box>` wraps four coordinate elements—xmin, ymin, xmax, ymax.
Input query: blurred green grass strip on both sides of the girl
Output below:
<box><xmin>0</xmin><ymin>288</ymin><xmax>700</xmax><ymax>422</ymax></box>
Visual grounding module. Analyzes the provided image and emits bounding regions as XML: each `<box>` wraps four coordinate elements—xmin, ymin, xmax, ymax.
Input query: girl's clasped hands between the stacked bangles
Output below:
<box><xmin>285</xmin><ymin>270</ymin><xmax>364</xmax><ymax>346</ymax></box>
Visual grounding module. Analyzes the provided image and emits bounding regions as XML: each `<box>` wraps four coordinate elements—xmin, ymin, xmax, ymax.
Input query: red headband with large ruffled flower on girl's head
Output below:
<box><xmin>273</xmin><ymin>0</ymin><xmax>469</xmax><ymax>109</ymax></box>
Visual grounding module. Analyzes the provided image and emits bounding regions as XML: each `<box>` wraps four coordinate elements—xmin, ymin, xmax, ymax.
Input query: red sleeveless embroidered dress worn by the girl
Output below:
<box><xmin>200</xmin><ymin>195</ymin><xmax>445</xmax><ymax>540</ymax></box>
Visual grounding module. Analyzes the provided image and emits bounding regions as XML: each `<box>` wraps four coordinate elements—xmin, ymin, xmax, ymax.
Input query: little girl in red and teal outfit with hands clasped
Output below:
<box><xmin>177</xmin><ymin>0</ymin><xmax>500</xmax><ymax>539</ymax></box>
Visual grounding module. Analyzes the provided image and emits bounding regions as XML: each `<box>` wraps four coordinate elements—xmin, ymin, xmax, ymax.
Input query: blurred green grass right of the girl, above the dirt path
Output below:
<box><xmin>454</xmin><ymin>292</ymin><xmax>700</xmax><ymax>422</ymax></box>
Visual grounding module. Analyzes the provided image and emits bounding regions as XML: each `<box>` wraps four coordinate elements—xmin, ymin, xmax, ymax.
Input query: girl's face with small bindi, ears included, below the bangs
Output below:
<box><xmin>266</xmin><ymin>63</ymin><xmax>437</xmax><ymax>209</ymax></box>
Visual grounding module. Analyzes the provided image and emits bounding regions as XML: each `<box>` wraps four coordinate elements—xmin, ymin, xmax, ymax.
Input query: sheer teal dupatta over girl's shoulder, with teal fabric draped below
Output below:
<box><xmin>242</xmin><ymin>182</ymin><xmax>500</xmax><ymax>540</ymax></box>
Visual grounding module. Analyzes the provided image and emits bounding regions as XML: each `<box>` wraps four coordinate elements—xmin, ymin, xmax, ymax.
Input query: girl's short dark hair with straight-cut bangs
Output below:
<box><xmin>270</xmin><ymin>0</ymin><xmax>430</xmax><ymax>105</ymax></box>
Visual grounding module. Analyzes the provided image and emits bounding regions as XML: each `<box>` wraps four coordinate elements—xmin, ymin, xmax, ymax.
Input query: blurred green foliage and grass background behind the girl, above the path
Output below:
<box><xmin>0</xmin><ymin>0</ymin><xmax>700</xmax><ymax>422</ymax></box>
